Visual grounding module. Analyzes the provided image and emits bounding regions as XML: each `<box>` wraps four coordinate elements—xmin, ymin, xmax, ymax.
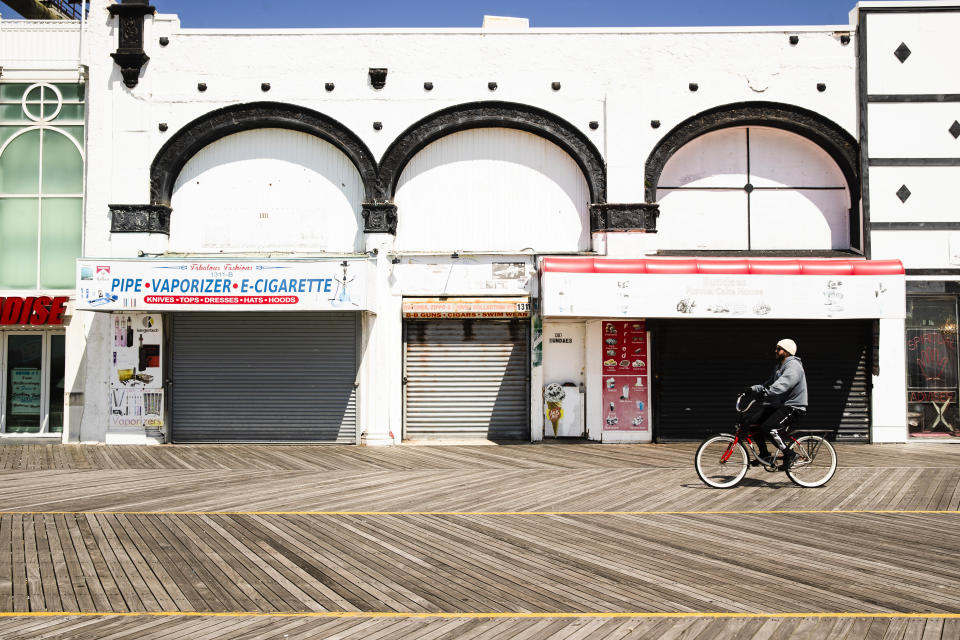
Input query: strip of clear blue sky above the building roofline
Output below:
<box><xmin>0</xmin><ymin>0</ymin><xmax>872</xmax><ymax>28</ymax></box>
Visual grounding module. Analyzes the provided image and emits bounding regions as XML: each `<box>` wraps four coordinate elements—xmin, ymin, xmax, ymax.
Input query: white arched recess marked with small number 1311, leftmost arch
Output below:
<box><xmin>167</xmin><ymin>128</ymin><xmax>364</xmax><ymax>253</ymax></box>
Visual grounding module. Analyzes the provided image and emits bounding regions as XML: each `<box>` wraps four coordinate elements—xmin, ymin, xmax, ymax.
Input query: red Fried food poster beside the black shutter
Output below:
<box><xmin>601</xmin><ymin>320</ymin><xmax>650</xmax><ymax>431</ymax></box>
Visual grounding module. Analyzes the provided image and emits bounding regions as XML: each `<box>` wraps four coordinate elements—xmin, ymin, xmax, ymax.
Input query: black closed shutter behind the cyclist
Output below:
<box><xmin>651</xmin><ymin>320</ymin><xmax>871</xmax><ymax>441</ymax></box>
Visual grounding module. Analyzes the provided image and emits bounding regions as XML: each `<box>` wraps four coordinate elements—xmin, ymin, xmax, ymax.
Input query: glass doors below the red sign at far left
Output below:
<box><xmin>0</xmin><ymin>332</ymin><xmax>65</xmax><ymax>435</ymax></box>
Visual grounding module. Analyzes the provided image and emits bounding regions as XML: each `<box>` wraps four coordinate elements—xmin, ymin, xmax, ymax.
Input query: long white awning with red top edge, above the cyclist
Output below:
<box><xmin>540</xmin><ymin>256</ymin><xmax>906</xmax><ymax>319</ymax></box>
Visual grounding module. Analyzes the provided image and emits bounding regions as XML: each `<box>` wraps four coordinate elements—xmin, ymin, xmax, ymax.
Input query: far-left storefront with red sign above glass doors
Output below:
<box><xmin>0</xmin><ymin>296</ymin><xmax>68</xmax><ymax>435</ymax></box>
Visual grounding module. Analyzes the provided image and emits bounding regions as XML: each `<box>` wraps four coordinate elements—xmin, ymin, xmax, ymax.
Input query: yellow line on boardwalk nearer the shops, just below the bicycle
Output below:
<box><xmin>0</xmin><ymin>509</ymin><xmax>960</xmax><ymax>516</ymax></box>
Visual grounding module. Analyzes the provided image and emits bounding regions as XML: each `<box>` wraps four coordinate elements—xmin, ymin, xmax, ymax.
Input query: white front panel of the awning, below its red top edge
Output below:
<box><xmin>542</xmin><ymin>272</ymin><xmax>906</xmax><ymax>319</ymax></box>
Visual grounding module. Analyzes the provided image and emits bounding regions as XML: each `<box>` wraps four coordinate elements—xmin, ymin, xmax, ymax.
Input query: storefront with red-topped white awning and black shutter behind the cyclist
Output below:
<box><xmin>541</xmin><ymin>258</ymin><xmax>904</xmax><ymax>442</ymax></box>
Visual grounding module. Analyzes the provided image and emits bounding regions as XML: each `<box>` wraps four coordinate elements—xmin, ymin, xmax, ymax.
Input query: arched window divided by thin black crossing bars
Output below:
<box><xmin>657</xmin><ymin>127</ymin><xmax>850</xmax><ymax>251</ymax></box>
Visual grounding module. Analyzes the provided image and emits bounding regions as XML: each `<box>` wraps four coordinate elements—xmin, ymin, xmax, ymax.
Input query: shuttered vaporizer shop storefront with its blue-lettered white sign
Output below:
<box><xmin>78</xmin><ymin>258</ymin><xmax>370</xmax><ymax>443</ymax></box>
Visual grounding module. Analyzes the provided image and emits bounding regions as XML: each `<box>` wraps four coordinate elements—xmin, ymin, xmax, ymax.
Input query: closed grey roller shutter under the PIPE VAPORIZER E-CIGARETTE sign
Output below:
<box><xmin>171</xmin><ymin>312</ymin><xmax>359</xmax><ymax>443</ymax></box>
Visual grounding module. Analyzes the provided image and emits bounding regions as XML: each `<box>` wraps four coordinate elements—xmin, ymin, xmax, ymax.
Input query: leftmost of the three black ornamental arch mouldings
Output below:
<box><xmin>150</xmin><ymin>102</ymin><xmax>378</xmax><ymax>206</ymax></box>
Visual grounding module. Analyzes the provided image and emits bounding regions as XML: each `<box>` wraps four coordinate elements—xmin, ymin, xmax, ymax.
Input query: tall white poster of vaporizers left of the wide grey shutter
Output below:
<box><xmin>110</xmin><ymin>312</ymin><xmax>163</xmax><ymax>428</ymax></box>
